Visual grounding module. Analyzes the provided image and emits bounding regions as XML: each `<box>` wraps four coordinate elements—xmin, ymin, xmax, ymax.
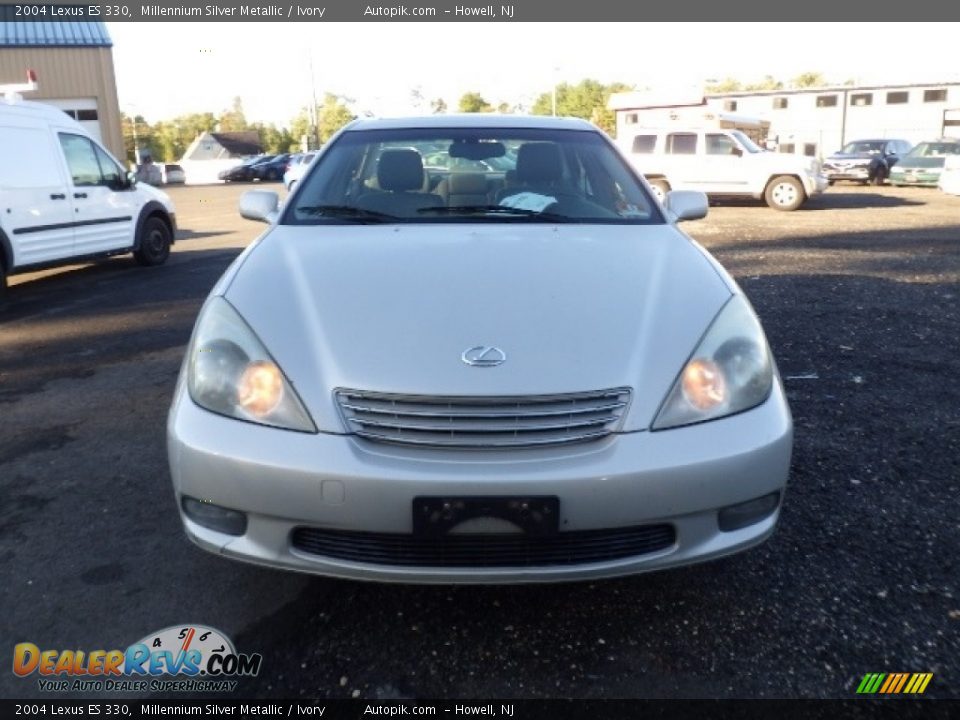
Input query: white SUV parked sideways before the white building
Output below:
<box><xmin>618</xmin><ymin>127</ymin><xmax>828</xmax><ymax>210</ymax></box>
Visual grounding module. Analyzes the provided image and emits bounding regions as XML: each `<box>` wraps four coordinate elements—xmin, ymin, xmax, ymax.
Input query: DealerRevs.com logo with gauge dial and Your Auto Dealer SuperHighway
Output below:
<box><xmin>13</xmin><ymin>625</ymin><xmax>263</xmax><ymax>692</ymax></box>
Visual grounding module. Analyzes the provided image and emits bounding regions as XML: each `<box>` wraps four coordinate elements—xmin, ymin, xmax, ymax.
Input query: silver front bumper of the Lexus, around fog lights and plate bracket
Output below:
<box><xmin>167</xmin><ymin>383</ymin><xmax>793</xmax><ymax>583</ymax></box>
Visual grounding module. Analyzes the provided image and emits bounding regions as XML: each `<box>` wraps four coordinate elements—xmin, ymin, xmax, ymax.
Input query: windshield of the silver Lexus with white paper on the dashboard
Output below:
<box><xmin>281</xmin><ymin>128</ymin><xmax>663</xmax><ymax>225</ymax></box>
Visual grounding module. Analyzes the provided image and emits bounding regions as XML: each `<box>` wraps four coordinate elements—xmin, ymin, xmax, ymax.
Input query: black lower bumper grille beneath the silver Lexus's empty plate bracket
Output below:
<box><xmin>292</xmin><ymin>524</ymin><xmax>676</xmax><ymax>568</ymax></box>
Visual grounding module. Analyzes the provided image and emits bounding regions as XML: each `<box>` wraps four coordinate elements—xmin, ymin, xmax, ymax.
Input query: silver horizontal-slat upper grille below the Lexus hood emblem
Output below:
<box><xmin>337</xmin><ymin>388</ymin><xmax>630</xmax><ymax>448</ymax></box>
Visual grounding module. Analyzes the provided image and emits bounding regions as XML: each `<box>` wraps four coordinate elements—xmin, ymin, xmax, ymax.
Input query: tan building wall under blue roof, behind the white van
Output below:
<box><xmin>0</xmin><ymin>47</ymin><xmax>126</xmax><ymax>164</ymax></box>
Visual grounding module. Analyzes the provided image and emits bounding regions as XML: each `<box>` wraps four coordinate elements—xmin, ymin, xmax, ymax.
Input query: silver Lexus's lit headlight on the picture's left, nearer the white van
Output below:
<box><xmin>187</xmin><ymin>297</ymin><xmax>317</xmax><ymax>432</ymax></box>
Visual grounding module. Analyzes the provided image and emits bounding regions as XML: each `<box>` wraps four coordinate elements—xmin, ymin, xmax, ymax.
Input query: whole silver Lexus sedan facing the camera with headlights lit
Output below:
<box><xmin>168</xmin><ymin>115</ymin><xmax>792</xmax><ymax>583</ymax></box>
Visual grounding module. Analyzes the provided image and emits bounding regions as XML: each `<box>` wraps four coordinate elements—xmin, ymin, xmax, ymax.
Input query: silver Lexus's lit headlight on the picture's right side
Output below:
<box><xmin>653</xmin><ymin>295</ymin><xmax>773</xmax><ymax>430</ymax></box>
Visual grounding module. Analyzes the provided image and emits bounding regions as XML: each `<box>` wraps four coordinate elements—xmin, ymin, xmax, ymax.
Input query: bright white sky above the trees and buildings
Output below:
<box><xmin>108</xmin><ymin>22</ymin><xmax>960</xmax><ymax>125</ymax></box>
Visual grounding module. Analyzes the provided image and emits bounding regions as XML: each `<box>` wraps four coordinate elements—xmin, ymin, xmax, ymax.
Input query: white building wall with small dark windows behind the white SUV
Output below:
<box><xmin>617</xmin><ymin>83</ymin><xmax>960</xmax><ymax>158</ymax></box>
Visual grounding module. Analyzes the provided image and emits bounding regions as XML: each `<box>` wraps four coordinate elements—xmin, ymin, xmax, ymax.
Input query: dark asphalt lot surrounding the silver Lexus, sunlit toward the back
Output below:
<box><xmin>0</xmin><ymin>185</ymin><xmax>960</xmax><ymax>698</ymax></box>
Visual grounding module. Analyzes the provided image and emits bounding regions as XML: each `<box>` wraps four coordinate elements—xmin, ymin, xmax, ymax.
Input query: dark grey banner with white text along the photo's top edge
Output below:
<box><xmin>0</xmin><ymin>0</ymin><xmax>960</xmax><ymax>21</ymax></box>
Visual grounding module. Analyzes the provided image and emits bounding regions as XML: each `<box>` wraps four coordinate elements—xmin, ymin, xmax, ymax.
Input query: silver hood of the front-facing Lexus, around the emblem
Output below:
<box><xmin>225</xmin><ymin>224</ymin><xmax>736</xmax><ymax>432</ymax></box>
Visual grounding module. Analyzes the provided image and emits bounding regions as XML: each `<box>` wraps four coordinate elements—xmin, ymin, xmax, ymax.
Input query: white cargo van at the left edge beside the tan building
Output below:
<box><xmin>0</xmin><ymin>86</ymin><xmax>176</xmax><ymax>294</ymax></box>
